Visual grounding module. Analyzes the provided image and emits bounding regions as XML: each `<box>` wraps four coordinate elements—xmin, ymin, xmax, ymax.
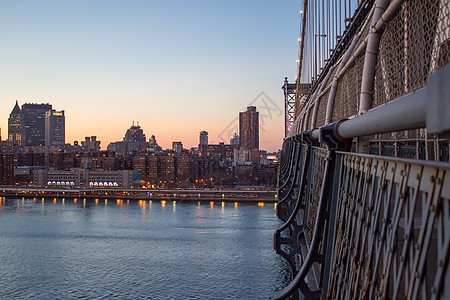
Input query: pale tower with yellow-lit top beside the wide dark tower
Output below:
<box><xmin>45</xmin><ymin>109</ymin><xmax>66</xmax><ymax>146</ymax></box>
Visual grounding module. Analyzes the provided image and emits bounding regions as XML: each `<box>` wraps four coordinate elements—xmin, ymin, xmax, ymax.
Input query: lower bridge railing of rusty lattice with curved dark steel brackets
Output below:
<box><xmin>274</xmin><ymin>128</ymin><xmax>450</xmax><ymax>299</ymax></box>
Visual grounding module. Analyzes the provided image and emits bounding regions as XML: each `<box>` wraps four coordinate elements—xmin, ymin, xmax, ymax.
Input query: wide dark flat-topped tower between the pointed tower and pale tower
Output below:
<box><xmin>22</xmin><ymin>103</ymin><xmax>52</xmax><ymax>146</ymax></box>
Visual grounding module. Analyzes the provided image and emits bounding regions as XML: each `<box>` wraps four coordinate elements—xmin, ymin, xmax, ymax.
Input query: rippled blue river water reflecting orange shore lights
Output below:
<box><xmin>0</xmin><ymin>198</ymin><xmax>290</xmax><ymax>299</ymax></box>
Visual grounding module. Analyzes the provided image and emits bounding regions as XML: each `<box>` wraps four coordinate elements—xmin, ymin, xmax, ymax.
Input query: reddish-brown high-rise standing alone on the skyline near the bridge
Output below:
<box><xmin>239</xmin><ymin>106</ymin><xmax>259</xmax><ymax>150</ymax></box>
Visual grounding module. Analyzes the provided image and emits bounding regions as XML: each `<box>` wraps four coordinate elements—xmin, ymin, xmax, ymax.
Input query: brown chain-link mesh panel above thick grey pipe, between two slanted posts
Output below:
<box><xmin>373</xmin><ymin>0</ymin><xmax>442</xmax><ymax>107</ymax></box>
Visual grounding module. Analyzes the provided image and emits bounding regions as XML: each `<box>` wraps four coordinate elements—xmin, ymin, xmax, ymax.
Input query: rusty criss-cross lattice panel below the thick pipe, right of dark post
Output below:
<box><xmin>328</xmin><ymin>153</ymin><xmax>450</xmax><ymax>299</ymax></box>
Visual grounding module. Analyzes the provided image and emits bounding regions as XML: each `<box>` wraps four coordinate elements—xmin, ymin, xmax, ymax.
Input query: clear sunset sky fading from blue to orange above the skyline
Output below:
<box><xmin>0</xmin><ymin>0</ymin><xmax>302</xmax><ymax>151</ymax></box>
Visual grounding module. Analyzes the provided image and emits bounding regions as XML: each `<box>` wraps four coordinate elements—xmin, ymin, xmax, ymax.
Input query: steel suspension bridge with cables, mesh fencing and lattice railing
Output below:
<box><xmin>273</xmin><ymin>0</ymin><xmax>450</xmax><ymax>299</ymax></box>
